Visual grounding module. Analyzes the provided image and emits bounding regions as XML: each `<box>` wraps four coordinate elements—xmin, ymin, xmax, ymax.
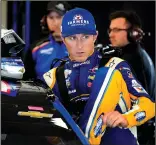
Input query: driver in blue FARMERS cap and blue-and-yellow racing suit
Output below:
<box><xmin>43</xmin><ymin>8</ymin><xmax>155</xmax><ymax>145</ymax></box>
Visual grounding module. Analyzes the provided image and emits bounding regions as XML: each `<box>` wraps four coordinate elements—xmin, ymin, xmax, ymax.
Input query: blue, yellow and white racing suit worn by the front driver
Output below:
<box><xmin>44</xmin><ymin>51</ymin><xmax>155</xmax><ymax>145</ymax></box>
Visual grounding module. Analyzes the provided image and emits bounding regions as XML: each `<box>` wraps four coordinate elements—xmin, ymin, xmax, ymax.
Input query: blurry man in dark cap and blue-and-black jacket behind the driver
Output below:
<box><xmin>24</xmin><ymin>1</ymin><xmax>70</xmax><ymax>80</ymax></box>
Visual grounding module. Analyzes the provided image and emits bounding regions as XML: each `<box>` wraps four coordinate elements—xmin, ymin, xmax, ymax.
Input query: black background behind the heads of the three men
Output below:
<box><xmin>8</xmin><ymin>1</ymin><xmax>155</xmax><ymax>63</ymax></box>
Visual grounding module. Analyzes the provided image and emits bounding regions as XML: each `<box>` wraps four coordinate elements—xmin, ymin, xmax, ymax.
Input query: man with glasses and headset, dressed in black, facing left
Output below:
<box><xmin>108</xmin><ymin>10</ymin><xmax>154</xmax><ymax>97</ymax></box>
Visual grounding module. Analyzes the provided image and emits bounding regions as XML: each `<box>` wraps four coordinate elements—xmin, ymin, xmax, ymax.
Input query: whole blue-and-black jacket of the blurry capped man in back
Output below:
<box><xmin>24</xmin><ymin>34</ymin><xmax>68</xmax><ymax>80</ymax></box>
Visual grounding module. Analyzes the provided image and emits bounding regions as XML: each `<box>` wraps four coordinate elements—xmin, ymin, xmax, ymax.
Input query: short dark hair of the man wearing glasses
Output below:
<box><xmin>109</xmin><ymin>10</ymin><xmax>142</xmax><ymax>28</ymax></box>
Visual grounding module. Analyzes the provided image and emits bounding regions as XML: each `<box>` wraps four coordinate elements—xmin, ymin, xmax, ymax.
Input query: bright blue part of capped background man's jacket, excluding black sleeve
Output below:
<box><xmin>32</xmin><ymin>35</ymin><xmax>68</xmax><ymax>80</ymax></box>
